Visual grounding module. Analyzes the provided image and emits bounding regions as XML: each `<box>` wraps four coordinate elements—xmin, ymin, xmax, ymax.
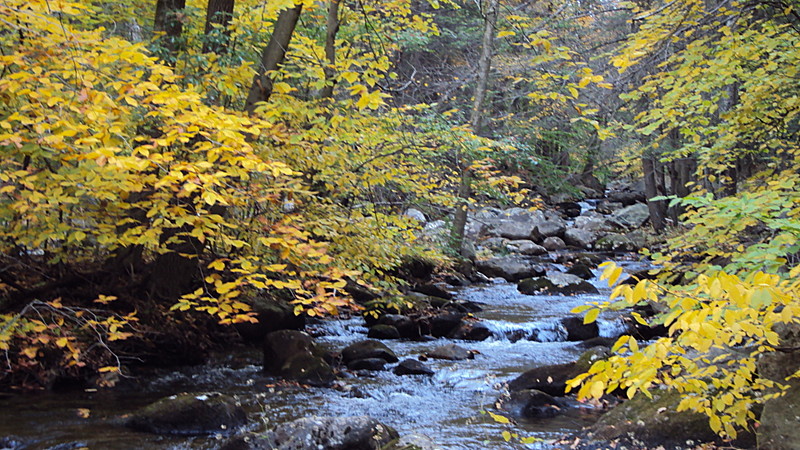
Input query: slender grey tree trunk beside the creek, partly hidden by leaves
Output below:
<box><xmin>450</xmin><ymin>0</ymin><xmax>498</xmax><ymax>254</ymax></box>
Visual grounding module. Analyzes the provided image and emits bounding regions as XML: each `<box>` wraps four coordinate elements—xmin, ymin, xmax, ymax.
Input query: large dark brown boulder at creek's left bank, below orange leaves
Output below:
<box><xmin>264</xmin><ymin>330</ymin><xmax>336</xmax><ymax>386</ymax></box>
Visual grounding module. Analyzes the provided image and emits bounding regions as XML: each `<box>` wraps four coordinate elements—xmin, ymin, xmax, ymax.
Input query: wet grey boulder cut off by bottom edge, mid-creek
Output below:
<box><xmin>264</xmin><ymin>416</ymin><xmax>399</xmax><ymax>450</ymax></box>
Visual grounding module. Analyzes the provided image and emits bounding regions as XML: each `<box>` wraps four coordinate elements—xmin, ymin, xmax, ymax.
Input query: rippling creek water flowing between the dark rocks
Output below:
<box><xmin>0</xmin><ymin>262</ymin><xmax>644</xmax><ymax>449</ymax></box>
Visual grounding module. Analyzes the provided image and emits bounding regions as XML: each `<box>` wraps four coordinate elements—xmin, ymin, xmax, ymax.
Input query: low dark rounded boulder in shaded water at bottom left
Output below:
<box><xmin>125</xmin><ymin>393</ymin><xmax>247</xmax><ymax>436</ymax></box>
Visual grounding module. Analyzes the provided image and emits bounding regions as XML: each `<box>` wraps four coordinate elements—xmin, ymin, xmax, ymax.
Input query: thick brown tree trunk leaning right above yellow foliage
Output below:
<box><xmin>244</xmin><ymin>3</ymin><xmax>303</xmax><ymax>114</ymax></box>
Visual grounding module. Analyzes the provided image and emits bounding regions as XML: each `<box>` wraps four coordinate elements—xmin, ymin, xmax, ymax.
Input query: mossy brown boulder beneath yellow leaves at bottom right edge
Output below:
<box><xmin>565</xmin><ymin>390</ymin><xmax>752</xmax><ymax>449</ymax></box>
